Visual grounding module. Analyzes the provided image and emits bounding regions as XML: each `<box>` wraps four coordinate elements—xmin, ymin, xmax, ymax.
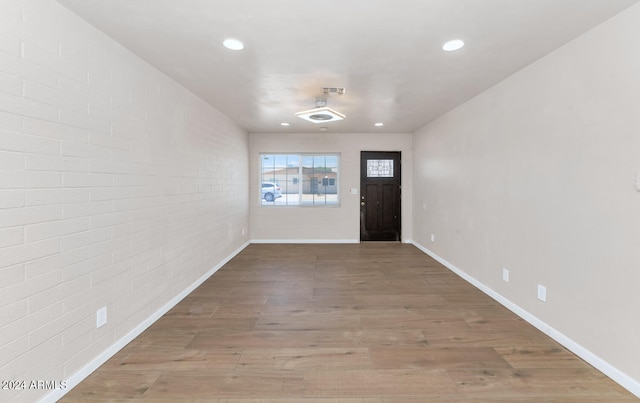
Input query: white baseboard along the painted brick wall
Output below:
<box><xmin>40</xmin><ymin>242</ymin><xmax>250</xmax><ymax>403</ymax></box>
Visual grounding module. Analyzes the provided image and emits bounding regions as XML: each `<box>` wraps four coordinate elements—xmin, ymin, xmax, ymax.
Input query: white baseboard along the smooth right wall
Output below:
<box><xmin>412</xmin><ymin>242</ymin><xmax>640</xmax><ymax>397</ymax></box>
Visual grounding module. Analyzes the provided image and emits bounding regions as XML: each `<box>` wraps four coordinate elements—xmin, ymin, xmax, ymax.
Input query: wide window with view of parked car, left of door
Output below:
<box><xmin>260</xmin><ymin>154</ymin><xmax>340</xmax><ymax>206</ymax></box>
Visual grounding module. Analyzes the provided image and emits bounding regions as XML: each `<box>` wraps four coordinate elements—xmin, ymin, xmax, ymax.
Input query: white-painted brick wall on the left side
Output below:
<box><xmin>0</xmin><ymin>0</ymin><xmax>249</xmax><ymax>401</ymax></box>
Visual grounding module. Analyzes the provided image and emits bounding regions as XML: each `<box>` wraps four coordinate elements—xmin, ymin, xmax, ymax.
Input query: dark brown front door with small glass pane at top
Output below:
<box><xmin>360</xmin><ymin>151</ymin><xmax>401</xmax><ymax>241</ymax></box>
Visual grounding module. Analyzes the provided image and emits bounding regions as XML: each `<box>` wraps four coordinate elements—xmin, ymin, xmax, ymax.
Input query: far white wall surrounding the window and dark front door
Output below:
<box><xmin>249</xmin><ymin>133</ymin><xmax>413</xmax><ymax>242</ymax></box>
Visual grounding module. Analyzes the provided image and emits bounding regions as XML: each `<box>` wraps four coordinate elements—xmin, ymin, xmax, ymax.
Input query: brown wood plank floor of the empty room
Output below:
<box><xmin>62</xmin><ymin>243</ymin><xmax>637</xmax><ymax>403</ymax></box>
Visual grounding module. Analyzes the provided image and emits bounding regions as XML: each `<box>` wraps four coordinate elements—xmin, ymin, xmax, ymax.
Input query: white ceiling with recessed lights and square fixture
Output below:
<box><xmin>59</xmin><ymin>0</ymin><xmax>639</xmax><ymax>133</ymax></box>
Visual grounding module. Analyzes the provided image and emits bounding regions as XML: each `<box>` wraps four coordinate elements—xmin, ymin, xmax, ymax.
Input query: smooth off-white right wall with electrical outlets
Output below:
<box><xmin>413</xmin><ymin>6</ymin><xmax>640</xmax><ymax>394</ymax></box>
